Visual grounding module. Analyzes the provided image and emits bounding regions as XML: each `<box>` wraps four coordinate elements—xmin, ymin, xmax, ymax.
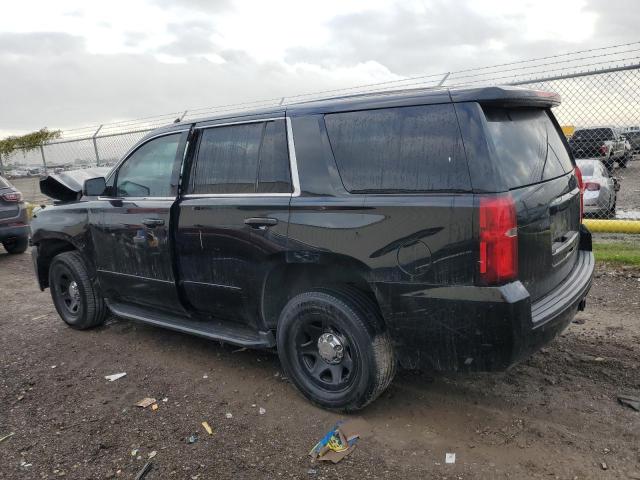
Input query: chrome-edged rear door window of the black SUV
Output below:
<box><xmin>191</xmin><ymin>120</ymin><xmax>291</xmax><ymax>194</ymax></box>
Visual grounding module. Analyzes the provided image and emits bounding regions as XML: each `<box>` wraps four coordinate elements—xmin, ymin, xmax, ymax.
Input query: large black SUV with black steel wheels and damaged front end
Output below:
<box><xmin>32</xmin><ymin>87</ymin><xmax>594</xmax><ymax>411</ymax></box>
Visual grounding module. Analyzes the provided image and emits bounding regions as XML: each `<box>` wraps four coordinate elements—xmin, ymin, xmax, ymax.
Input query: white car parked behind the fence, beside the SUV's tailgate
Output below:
<box><xmin>576</xmin><ymin>159</ymin><xmax>620</xmax><ymax>218</ymax></box>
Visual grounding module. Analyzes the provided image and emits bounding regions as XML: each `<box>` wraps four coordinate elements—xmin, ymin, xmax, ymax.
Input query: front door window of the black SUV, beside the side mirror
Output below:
<box><xmin>116</xmin><ymin>133</ymin><xmax>183</xmax><ymax>197</ymax></box>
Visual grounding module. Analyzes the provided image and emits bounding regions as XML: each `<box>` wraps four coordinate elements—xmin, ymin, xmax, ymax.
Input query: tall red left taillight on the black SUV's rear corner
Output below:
<box><xmin>479</xmin><ymin>195</ymin><xmax>518</xmax><ymax>285</ymax></box>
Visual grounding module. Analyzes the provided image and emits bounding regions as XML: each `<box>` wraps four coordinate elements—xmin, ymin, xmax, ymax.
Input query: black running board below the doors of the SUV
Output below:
<box><xmin>105</xmin><ymin>300</ymin><xmax>276</xmax><ymax>348</ymax></box>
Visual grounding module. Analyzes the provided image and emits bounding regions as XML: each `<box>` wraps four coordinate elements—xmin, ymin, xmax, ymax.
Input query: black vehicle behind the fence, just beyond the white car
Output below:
<box><xmin>569</xmin><ymin>127</ymin><xmax>628</xmax><ymax>170</ymax></box>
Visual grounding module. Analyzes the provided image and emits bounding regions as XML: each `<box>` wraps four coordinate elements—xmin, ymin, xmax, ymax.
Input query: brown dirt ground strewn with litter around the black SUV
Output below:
<box><xmin>0</xmin><ymin>251</ymin><xmax>640</xmax><ymax>479</ymax></box>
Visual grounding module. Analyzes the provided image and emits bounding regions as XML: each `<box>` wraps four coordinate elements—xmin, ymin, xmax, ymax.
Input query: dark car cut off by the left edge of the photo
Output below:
<box><xmin>0</xmin><ymin>177</ymin><xmax>29</xmax><ymax>253</ymax></box>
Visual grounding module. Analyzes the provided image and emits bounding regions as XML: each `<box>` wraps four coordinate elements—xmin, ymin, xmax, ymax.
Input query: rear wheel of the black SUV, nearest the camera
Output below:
<box><xmin>277</xmin><ymin>289</ymin><xmax>396</xmax><ymax>412</ymax></box>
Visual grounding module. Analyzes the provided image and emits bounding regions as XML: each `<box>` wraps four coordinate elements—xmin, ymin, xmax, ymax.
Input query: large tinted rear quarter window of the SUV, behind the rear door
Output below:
<box><xmin>325</xmin><ymin>104</ymin><xmax>471</xmax><ymax>193</ymax></box>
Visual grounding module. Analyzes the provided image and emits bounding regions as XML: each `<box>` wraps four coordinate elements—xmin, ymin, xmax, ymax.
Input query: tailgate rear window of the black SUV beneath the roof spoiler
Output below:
<box><xmin>484</xmin><ymin>107</ymin><xmax>573</xmax><ymax>188</ymax></box>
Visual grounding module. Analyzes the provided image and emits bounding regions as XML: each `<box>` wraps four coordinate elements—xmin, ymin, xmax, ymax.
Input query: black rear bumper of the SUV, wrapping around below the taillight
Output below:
<box><xmin>378</xmin><ymin>250</ymin><xmax>595</xmax><ymax>371</ymax></box>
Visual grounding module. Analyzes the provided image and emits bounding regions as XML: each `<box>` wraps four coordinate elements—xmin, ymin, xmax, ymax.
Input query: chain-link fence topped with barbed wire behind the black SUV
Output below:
<box><xmin>2</xmin><ymin>42</ymin><xmax>640</xmax><ymax>231</ymax></box>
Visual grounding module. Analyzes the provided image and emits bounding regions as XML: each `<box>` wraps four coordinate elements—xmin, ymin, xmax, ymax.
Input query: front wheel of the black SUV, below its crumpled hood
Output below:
<box><xmin>49</xmin><ymin>252</ymin><xmax>106</xmax><ymax>330</ymax></box>
